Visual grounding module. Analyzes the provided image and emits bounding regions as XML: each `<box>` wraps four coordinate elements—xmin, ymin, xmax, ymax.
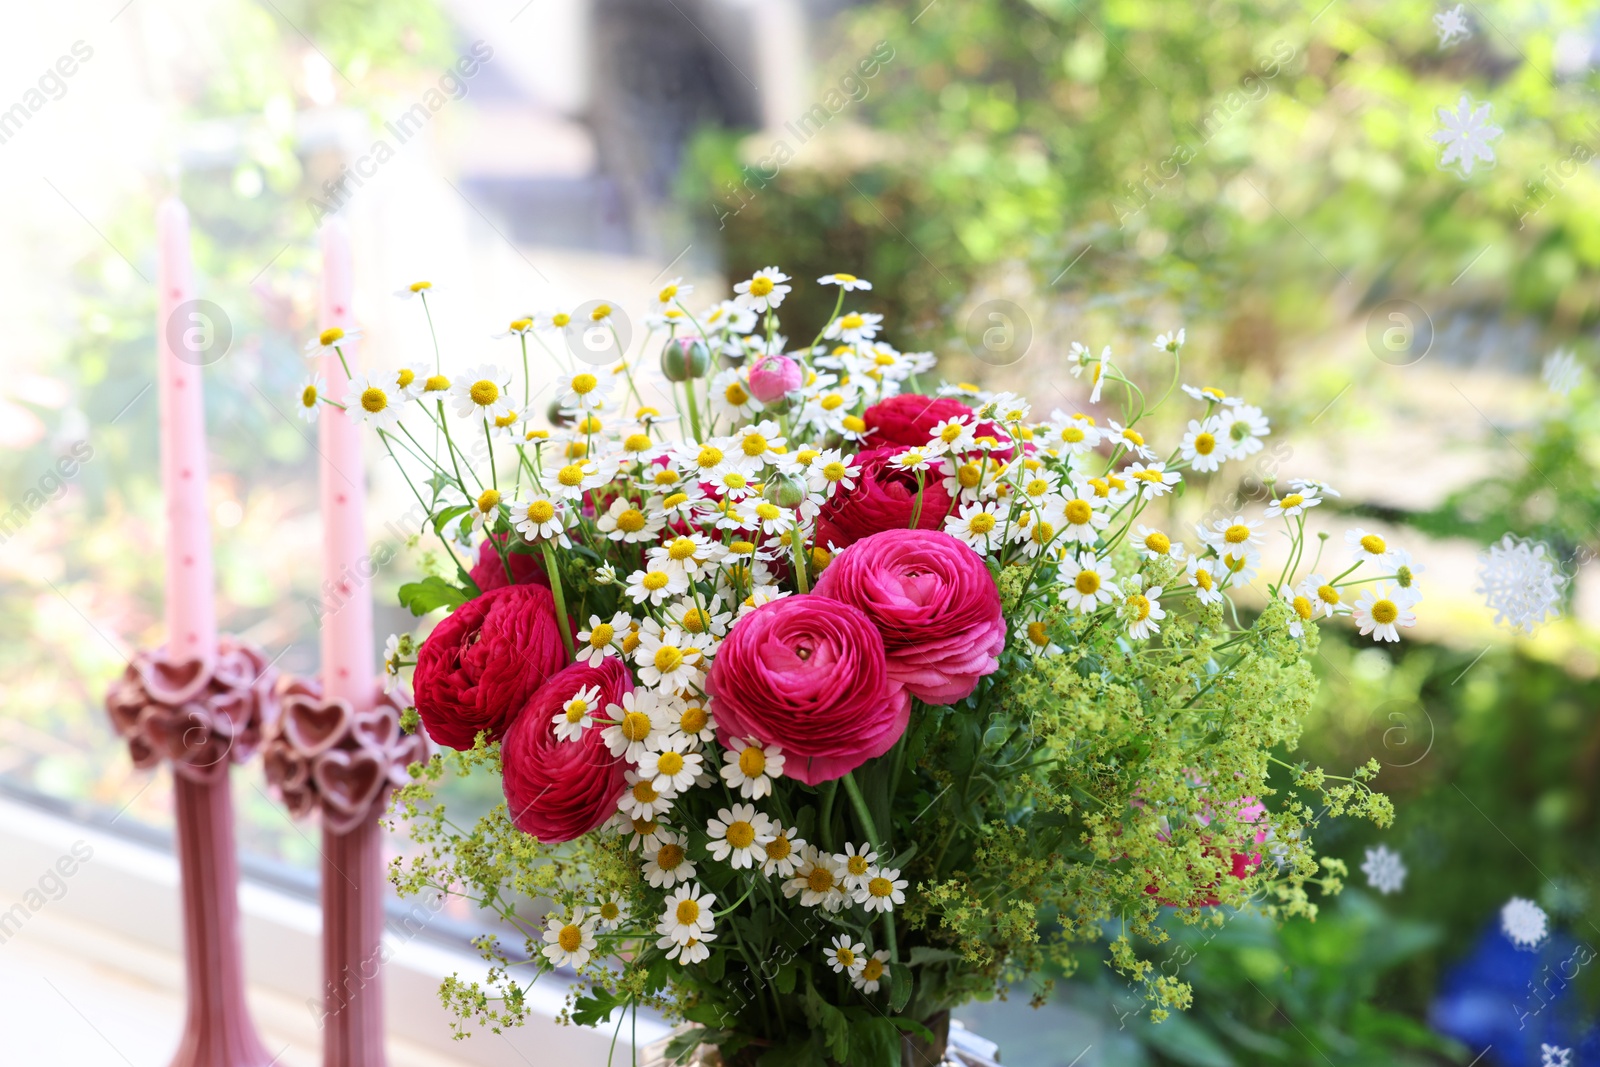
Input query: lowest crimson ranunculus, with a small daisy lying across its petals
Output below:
<box><xmin>501</xmin><ymin>656</ymin><xmax>634</xmax><ymax>843</ymax></box>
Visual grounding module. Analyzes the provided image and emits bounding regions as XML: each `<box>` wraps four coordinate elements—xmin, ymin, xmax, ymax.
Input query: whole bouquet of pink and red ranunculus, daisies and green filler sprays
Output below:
<box><xmin>304</xmin><ymin>267</ymin><xmax>1419</xmax><ymax>1067</ymax></box>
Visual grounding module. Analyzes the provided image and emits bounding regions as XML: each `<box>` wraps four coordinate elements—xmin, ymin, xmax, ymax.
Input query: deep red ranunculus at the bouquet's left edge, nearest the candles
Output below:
<box><xmin>411</xmin><ymin>585</ymin><xmax>566</xmax><ymax>749</ymax></box>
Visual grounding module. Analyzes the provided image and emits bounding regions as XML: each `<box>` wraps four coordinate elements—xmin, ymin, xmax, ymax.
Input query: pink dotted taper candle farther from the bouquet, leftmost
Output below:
<box><xmin>155</xmin><ymin>200</ymin><xmax>216</xmax><ymax>664</ymax></box>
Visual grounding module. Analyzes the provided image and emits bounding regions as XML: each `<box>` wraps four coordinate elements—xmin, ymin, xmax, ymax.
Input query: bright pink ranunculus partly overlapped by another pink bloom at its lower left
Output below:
<box><xmin>814</xmin><ymin>530</ymin><xmax>1005</xmax><ymax>704</ymax></box>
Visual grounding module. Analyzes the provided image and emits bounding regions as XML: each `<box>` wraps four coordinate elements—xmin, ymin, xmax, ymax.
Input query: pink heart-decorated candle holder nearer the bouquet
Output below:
<box><xmin>262</xmin><ymin>677</ymin><xmax>427</xmax><ymax>1067</ymax></box>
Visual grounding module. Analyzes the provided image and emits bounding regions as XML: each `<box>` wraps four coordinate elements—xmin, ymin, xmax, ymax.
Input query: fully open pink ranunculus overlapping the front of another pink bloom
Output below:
<box><xmin>706</xmin><ymin>595</ymin><xmax>910</xmax><ymax>785</ymax></box>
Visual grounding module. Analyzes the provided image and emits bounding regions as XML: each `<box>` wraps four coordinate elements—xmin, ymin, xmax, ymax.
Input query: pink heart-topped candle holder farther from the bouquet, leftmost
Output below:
<box><xmin>106</xmin><ymin>635</ymin><xmax>277</xmax><ymax>1067</ymax></box>
